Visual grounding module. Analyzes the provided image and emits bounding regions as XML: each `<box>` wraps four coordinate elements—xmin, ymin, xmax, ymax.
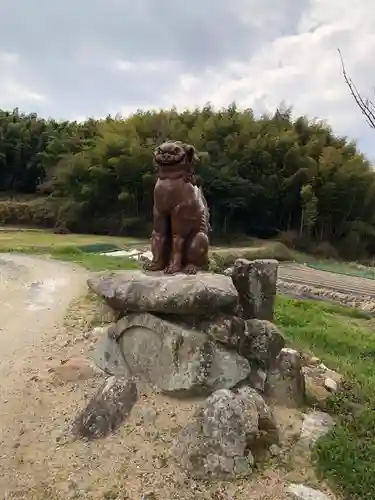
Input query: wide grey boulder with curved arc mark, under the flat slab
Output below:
<box><xmin>94</xmin><ymin>313</ymin><xmax>250</xmax><ymax>397</ymax></box>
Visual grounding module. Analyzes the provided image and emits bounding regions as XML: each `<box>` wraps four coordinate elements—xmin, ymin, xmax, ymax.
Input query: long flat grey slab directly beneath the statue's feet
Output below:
<box><xmin>87</xmin><ymin>271</ymin><xmax>238</xmax><ymax>315</ymax></box>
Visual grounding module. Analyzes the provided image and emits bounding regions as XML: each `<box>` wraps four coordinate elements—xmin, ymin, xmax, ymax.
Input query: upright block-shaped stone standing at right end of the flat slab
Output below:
<box><xmin>232</xmin><ymin>259</ymin><xmax>279</xmax><ymax>321</ymax></box>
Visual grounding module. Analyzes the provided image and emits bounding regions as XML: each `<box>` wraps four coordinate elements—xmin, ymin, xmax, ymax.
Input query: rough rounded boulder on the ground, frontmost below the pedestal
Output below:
<box><xmin>173</xmin><ymin>387</ymin><xmax>278</xmax><ymax>479</ymax></box>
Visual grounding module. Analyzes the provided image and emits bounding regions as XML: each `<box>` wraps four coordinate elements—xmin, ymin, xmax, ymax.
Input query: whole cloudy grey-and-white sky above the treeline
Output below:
<box><xmin>0</xmin><ymin>0</ymin><xmax>375</xmax><ymax>159</ymax></box>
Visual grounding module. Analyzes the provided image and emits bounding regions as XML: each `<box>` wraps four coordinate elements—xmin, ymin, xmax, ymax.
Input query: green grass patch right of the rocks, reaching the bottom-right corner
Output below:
<box><xmin>276</xmin><ymin>297</ymin><xmax>375</xmax><ymax>500</ymax></box>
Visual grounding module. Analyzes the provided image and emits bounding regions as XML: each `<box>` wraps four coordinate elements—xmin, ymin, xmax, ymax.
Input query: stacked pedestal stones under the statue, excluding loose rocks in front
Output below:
<box><xmin>88</xmin><ymin>259</ymin><xmax>285</xmax><ymax>397</ymax></box>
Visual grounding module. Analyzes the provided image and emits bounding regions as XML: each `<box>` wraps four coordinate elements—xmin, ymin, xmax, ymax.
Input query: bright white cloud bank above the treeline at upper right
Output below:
<box><xmin>164</xmin><ymin>0</ymin><xmax>375</xmax><ymax>157</ymax></box>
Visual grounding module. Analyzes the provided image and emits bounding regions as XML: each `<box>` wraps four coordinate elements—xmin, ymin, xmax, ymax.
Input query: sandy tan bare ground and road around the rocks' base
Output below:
<box><xmin>0</xmin><ymin>255</ymin><xmax>338</xmax><ymax>500</ymax></box>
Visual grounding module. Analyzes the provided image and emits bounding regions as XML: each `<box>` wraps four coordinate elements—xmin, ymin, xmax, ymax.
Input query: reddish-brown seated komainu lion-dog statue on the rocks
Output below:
<box><xmin>146</xmin><ymin>141</ymin><xmax>210</xmax><ymax>274</ymax></box>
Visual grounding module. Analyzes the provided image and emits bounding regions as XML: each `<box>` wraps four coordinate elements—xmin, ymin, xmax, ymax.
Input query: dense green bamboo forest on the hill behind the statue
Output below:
<box><xmin>0</xmin><ymin>103</ymin><xmax>375</xmax><ymax>258</ymax></box>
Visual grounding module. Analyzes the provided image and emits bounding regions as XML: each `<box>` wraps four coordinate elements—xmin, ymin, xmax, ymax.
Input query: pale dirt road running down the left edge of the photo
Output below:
<box><xmin>0</xmin><ymin>254</ymin><xmax>87</xmax><ymax>498</ymax></box>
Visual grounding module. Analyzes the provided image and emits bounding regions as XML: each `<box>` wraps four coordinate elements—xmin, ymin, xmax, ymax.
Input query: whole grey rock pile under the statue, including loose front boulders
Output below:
<box><xmin>80</xmin><ymin>259</ymin><xmax>339</xmax><ymax>479</ymax></box>
